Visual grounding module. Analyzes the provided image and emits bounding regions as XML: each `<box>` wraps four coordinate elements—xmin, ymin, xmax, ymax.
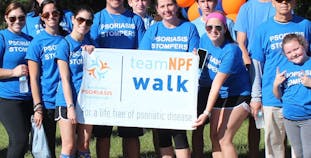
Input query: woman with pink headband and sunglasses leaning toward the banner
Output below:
<box><xmin>195</xmin><ymin>12</ymin><xmax>251</xmax><ymax>158</ymax></box>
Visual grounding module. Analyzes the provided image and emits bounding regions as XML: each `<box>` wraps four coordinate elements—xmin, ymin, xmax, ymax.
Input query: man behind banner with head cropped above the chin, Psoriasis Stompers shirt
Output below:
<box><xmin>90</xmin><ymin>0</ymin><xmax>145</xmax><ymax>158</ymax></box>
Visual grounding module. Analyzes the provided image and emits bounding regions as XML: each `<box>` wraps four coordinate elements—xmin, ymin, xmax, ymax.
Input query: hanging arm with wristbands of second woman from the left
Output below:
<box><xmin>28</xmin><ymin>60</ymin><xmax>43</xmax><ymax>126</ymax></box>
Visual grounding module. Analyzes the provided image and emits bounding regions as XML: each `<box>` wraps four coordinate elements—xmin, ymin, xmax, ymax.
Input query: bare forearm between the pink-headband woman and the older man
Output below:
<box><xmin>237</xmin><ymin>31</ymin><xmax>251</xmax><ymax>66</ymax></box>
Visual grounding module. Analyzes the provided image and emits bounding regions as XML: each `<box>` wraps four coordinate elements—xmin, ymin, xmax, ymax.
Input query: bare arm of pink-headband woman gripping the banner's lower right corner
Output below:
<box><xmin>194</xmin><ymin>72</ymin><xmax>229</xmax><ymax>127</ymax></box>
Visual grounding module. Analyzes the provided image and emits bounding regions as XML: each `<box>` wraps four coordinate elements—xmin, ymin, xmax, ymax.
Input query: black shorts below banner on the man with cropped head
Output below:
<box><xmin>93</xmin><ymin>125</ymin><xmax>144</xmax><ymax>138</ymax></box>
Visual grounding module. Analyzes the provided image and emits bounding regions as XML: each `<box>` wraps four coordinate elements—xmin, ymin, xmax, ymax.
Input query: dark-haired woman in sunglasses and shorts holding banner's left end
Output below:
<box><xmin>55</xmin><ymin>6</ymin><xmax>93</xmax><ymax>158</ymax></box>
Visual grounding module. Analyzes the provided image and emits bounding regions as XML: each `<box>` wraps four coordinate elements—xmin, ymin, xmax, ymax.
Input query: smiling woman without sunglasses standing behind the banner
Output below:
<box><xmin>139</xmin><ymin>0</ymin><xmax>200</xmax><ymax>158</ymax></box>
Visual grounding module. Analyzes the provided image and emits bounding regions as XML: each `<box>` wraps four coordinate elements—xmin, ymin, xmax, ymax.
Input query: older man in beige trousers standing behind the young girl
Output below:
<box><xmin>249</xmin><ymin>0</ymin><xmax>311</xmax><ymax>158</ymax></box>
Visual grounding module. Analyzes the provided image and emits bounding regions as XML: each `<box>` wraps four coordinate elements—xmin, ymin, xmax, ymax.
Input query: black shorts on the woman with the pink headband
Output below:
<box><xmin>214</xmin><ymin>95</ymin><xmax>251</xmax><ymax>109</ymax></box>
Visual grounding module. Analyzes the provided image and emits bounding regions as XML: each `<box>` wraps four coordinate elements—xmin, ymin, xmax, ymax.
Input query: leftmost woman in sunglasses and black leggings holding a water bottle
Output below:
<box><xmin>0</xmin><ymin>2</ymin><xmax>33</xmax><ymax>158</ymax></box>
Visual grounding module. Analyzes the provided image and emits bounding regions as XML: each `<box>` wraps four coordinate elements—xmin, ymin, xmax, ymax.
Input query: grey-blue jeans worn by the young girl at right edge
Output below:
<box><xmin>284</xmin><ymin>119</ymin><xmax>311</xmax><ymax>158</ymax></box>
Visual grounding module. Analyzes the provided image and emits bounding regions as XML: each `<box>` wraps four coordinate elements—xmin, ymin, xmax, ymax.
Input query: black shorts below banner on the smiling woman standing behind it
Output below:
<box><xmin>157</xmin><ymin>129</ymin><xmax>189</xmax><ymax>149</ymax></box>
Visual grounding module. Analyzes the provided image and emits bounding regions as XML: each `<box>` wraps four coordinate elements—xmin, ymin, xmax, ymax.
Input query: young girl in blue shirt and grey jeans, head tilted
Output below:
<box><xmin>273</xmin><ymin>34</ymin><xmax>311</xmax><ymax>158</ymax></box>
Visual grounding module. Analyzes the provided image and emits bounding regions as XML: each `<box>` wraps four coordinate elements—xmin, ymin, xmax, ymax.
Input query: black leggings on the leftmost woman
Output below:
<box><xmin>0</xmin><ymin>98</ymin><xmax>33</xmax><ymax>158</ymax></box>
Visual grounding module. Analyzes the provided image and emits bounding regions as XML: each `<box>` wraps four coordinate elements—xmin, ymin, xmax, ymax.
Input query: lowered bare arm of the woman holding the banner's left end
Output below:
<box><xmin>57</xmin><ymin>60</ymin><xmax>77</xmax><ymax>124</ymax></box>
